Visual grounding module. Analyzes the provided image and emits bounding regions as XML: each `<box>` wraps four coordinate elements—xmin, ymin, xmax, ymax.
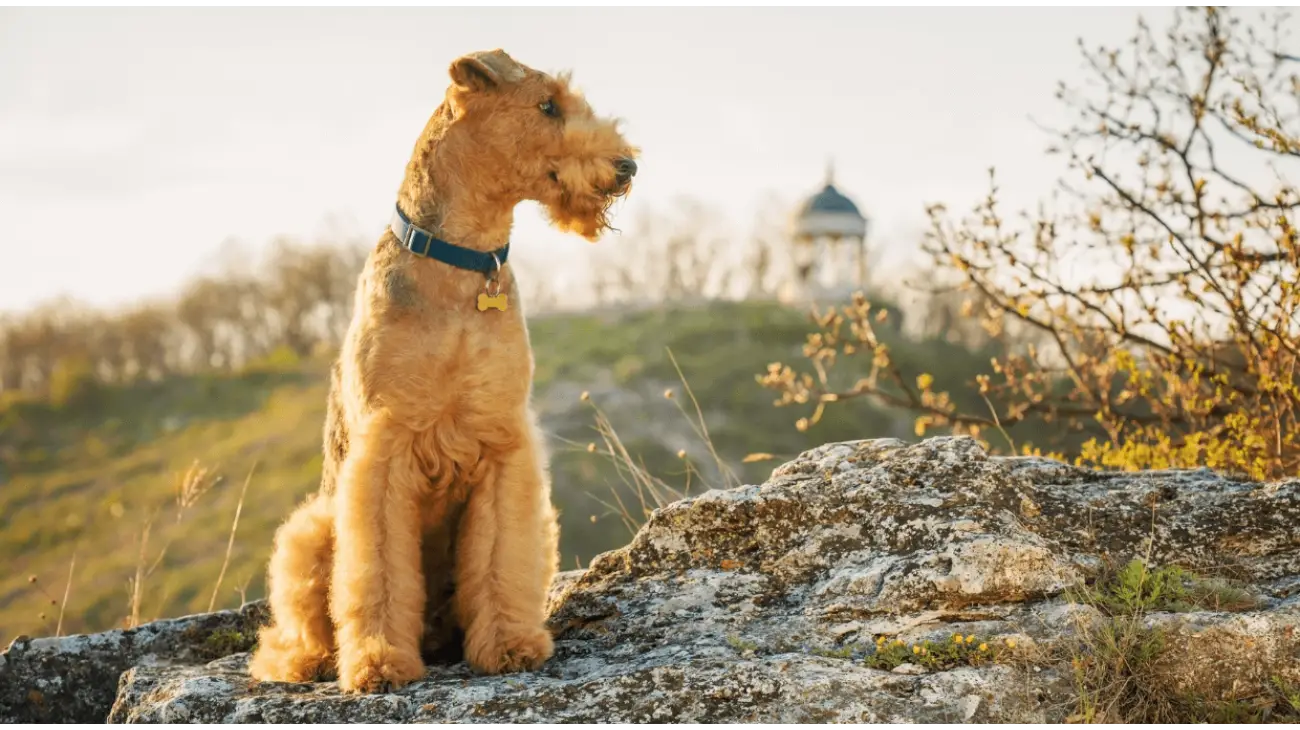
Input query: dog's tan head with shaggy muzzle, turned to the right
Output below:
<box><xmin>443</xmin><ymin>49</ymin><xmax>638</xmax><ymax>240</ymax></box>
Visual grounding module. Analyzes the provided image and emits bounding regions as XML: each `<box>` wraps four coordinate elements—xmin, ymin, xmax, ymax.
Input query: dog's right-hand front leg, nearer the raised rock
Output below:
<box><xmin>455</xmin><ymin>422</ymin><xmax>556</xmax><ymax>674</ymax></box>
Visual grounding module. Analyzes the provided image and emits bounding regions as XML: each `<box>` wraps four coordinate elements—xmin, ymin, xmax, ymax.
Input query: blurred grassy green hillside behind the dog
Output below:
<box><xmin>0</xmin><ymin>303</ymin><xmax>1003</xmax><ymax>646</ymax></box>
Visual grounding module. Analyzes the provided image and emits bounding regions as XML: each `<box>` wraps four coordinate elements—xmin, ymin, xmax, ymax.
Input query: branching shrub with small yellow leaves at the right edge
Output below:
<box><xmin>759</xmin><ymin>8</ymin><xmax>1300</xmax><ymax>478</ymax></box>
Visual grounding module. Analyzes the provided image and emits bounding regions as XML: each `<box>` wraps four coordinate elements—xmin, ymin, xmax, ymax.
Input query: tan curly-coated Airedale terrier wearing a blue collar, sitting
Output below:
<box><xmin>250</xmin><ymin>49</ymin><xmax>638</xmax><ymax>692</ymax></box>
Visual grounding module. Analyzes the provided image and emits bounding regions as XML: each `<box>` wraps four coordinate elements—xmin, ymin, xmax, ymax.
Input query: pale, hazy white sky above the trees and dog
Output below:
<box><xmin>0</xmin><ymin>0</ymin><xmax>1289</xmax><ymax>310</ymax></box>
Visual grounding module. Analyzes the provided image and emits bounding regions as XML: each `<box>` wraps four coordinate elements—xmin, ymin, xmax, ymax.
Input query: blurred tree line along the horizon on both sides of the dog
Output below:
<box><xmin>0</xmin><ymin>200</ymin><xmax>982</xmax><ymax>397</ymax></box>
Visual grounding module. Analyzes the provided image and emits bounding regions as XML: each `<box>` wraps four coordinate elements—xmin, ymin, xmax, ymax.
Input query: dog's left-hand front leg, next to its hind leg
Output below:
<box><xmin>330</xmin><ymin>416</ymin><xmax>425</xmax><ymax>692</ymax></box>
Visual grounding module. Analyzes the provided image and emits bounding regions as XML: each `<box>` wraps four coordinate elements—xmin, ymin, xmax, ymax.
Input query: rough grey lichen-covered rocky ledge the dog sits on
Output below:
<box><xmin>0</xmin><ymin>438</ymin><xmax>1300</xmax><ymax>725</ymax></box>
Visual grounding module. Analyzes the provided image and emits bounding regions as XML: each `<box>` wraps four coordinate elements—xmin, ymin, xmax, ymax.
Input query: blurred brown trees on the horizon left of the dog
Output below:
<box><xmin>0</xmin><ymin>232</ymin><xmax>368</xmax><ymax>397</ymax></box>
